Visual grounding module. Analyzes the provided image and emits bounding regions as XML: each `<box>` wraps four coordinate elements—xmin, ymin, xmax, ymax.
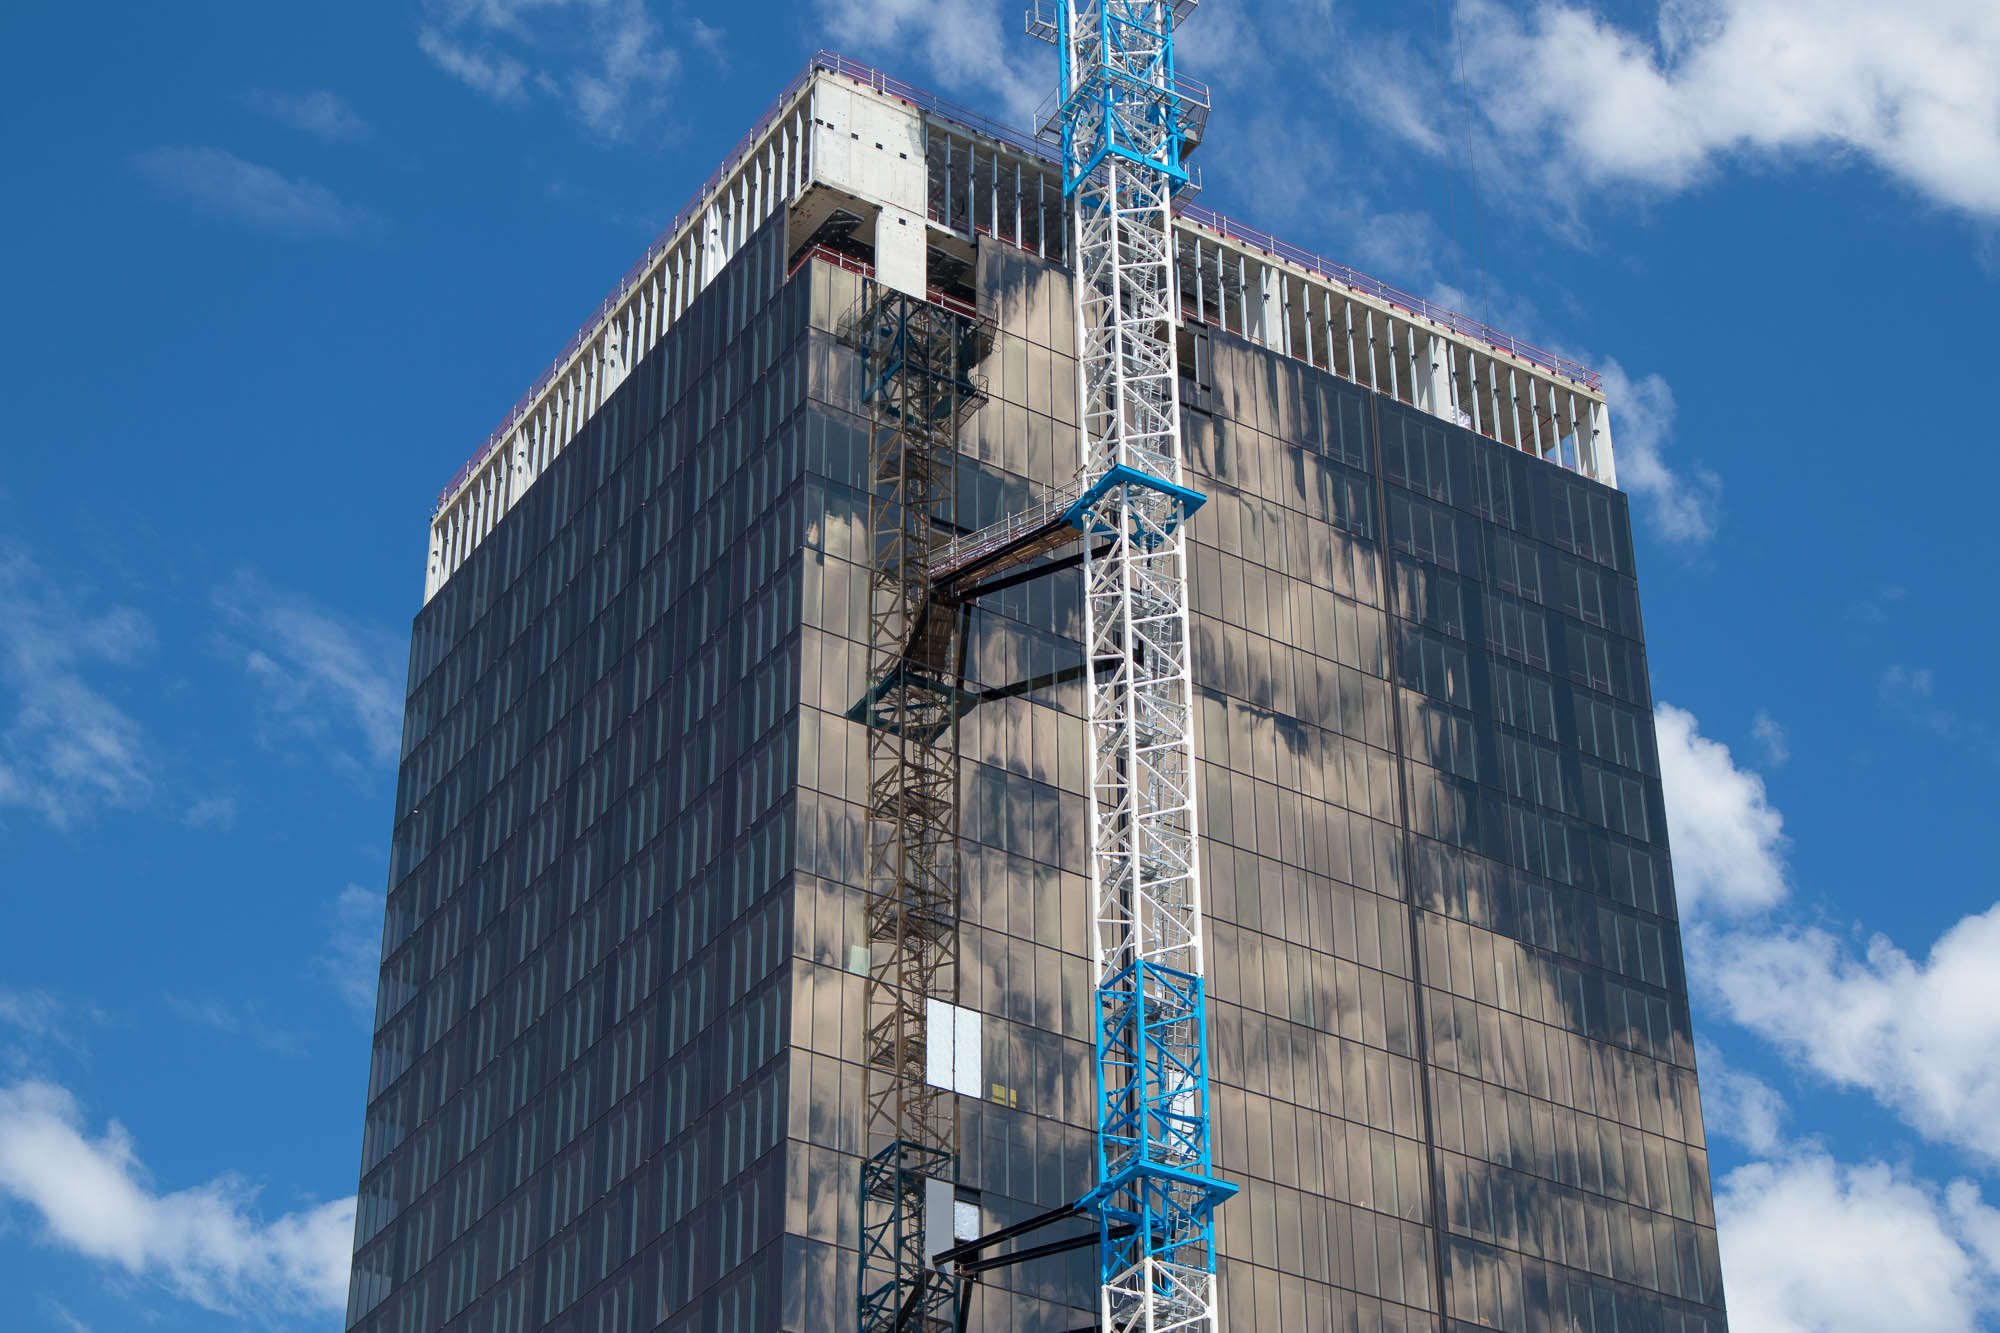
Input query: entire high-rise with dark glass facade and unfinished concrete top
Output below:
<box><xmin>348</xmin><ymin>36</ymin><xmax>1726</xmax><ymax>1333</ymax></box>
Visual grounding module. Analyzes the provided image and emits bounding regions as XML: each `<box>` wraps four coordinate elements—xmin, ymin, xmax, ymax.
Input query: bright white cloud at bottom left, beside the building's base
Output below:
<box><xmin>0</xmin><ymin>1081</ymin><xmax>354</xmax><ymax>1317</ymax></box>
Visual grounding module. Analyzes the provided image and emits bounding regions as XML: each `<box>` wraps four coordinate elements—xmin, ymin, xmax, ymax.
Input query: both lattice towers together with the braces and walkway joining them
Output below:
<box><xmin>844</xmin><ymin>0</ymin><xmax>1236</xmax><ymax>1333</ymax></box>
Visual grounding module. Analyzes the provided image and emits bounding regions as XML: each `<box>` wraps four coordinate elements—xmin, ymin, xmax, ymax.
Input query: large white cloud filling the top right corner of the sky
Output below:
<box><xmin>1416</xmin><ymin>0</ymin><xmax>2000</xmax><ymax>218</ymax></box>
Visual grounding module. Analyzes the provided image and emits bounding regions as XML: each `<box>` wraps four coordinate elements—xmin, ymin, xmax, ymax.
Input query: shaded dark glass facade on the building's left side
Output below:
<box><xmin>348</xmin><ymin>224</ymin><xmax>808</xmax><ymax>1333</ymax></box>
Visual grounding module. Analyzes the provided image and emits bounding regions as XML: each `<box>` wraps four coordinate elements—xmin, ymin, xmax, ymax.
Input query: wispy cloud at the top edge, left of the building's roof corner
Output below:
<box><xmin>416</xmin><ymin>0</ymin><xmax>680</xmax><ymax>138</ymax></box>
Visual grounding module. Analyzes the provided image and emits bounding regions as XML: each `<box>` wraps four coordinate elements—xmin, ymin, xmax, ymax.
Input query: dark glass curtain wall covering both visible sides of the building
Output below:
<box><xmin>348</xmin><ymin>210</ymin><xmax>1724</xmax><ymax>1333</ymax></box>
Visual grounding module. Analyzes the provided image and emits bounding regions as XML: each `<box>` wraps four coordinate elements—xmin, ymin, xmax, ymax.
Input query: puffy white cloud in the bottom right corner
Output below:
<box><xmin>1716</xmin><ymin>1147</ymin><xmax>2000</xmax><ymax>1333</ymax></box>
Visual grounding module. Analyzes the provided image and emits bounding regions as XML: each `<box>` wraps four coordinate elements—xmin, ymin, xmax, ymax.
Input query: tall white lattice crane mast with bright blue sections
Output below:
<box><xmin>1028</xmin><ymin>0</ymin><xmax>1234</xmax><ymax>1333</ymax></box>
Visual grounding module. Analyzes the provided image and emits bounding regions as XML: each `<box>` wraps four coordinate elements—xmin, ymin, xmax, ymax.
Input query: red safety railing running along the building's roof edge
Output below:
<box><xmin>438</xmin><ymin>50</ymin><xmax>1600</xmax><ymax>510</ymax></box>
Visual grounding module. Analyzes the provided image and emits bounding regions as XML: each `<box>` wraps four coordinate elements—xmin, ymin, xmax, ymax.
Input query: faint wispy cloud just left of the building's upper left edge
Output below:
<box><xmin>216</xmin><ymin>572</ymin><xmax>406</xmax><ymax>769</ymax></box>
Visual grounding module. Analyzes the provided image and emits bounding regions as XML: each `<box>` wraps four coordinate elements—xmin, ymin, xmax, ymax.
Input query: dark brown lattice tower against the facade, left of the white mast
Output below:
<box><xmin>844</xmin><ymin>280</ymin><xmax>992</xmax><ymax>1333</ymax></box>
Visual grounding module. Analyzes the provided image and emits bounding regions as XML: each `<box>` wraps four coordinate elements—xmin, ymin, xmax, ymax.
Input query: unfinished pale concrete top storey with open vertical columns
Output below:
<box><xmin>424</xmin><ymin>52</ymin><xmax>1616</xmax><ymax>600</ymax></box>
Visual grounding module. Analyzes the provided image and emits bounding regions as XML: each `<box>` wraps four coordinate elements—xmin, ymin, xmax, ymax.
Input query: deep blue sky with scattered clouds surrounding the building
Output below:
<box><xmin>0</xmin><ymin>0</ymin><xmax>2000</xmax><ymax>1333</ymax></box>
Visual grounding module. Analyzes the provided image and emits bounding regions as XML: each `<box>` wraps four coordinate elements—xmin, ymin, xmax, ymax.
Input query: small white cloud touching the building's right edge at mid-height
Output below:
<box><xmin>1654</xmin><ymin>703</ymin><xmax>1786</xmax><ymax>919</ymax></box>
